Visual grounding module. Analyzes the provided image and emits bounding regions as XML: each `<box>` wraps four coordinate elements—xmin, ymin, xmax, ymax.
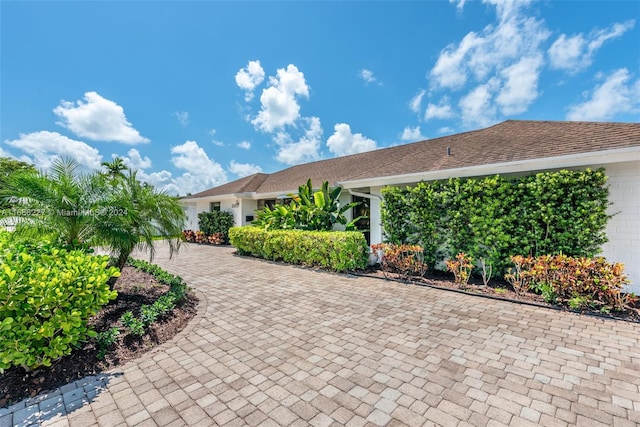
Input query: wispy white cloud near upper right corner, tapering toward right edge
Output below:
<box><xmin>548</xmin><ymin>20</ymin><xmax>635</xmax><ymax>74</ymax></box>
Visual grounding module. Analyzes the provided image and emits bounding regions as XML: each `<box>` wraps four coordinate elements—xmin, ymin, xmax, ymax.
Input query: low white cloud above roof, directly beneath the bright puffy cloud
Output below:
<box><xmin>274</xmin><ymin>117</ymin><xmax>322</xmax><ymax>165</ymax></box>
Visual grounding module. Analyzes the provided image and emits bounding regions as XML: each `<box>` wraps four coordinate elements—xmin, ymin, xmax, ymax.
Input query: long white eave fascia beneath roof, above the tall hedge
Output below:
<box><xmin>338</xmin><ymin>146</ymin><xmax>640</xmax><ymax>188</ymax></box>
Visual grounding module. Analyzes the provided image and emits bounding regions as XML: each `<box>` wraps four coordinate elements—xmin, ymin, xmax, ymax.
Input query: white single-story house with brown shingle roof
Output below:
<box><xmin>182</xmin><ymin>120</ymin><xmax>640</xmax><ymax>294</ymax></box>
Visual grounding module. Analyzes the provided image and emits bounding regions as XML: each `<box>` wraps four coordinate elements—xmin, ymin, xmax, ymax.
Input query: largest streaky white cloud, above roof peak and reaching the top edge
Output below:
<box><xmin>424</xmin><ymin>0</ymin><xmax>550</xmax><ymax>126</ymax></box>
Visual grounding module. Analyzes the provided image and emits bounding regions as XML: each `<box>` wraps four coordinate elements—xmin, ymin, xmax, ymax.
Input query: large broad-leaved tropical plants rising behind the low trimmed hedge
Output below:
<box><xmin>253</xmin><ymin>179</ymin><xmax>361</xmax><ymax>231</ymax></box>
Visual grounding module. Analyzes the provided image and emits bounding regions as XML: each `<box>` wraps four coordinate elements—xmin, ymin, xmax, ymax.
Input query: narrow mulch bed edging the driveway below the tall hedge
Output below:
<box><xmin>359</xmin><ymin>266</ymin><xmax>640</xmax><ymax>323</ymax></box>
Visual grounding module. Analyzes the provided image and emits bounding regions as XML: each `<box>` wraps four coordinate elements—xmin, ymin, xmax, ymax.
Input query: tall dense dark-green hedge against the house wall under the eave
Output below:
<box><xmin>381</xmin><ymin>169</ymin><xmax>609</xmax><ymax>275</ymax></box>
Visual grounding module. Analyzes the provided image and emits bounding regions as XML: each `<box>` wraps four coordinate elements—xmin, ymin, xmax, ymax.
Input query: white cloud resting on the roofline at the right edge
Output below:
<box><xmin>567</xmin><ymin>68</ymin><xmax>640</xmax><ymax>121</ymax></box>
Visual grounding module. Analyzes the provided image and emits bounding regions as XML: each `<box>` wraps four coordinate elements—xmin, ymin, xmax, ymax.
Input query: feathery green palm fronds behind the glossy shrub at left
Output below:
<box><xmin>2</xmin><ymin>159</ymin><xmax>185</xmax><ymax>268</ymax></box>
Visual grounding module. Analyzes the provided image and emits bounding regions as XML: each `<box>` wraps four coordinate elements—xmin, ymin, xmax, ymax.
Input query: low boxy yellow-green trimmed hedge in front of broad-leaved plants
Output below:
<box><xmin>229</xmin><ymin>227</ymin><xmax>369</xmax><ymax>272</ymax></box>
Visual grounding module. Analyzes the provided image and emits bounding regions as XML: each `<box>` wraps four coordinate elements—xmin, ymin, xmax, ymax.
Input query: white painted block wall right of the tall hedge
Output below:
<box><xmin>602</xmin><ymin>161</ymin><xmax>640</xmax><ymax>294</ymax></box>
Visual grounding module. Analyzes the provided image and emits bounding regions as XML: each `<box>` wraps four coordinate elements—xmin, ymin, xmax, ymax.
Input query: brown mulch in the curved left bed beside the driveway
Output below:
<box><xmin>0</xmin><ymin>267</ymin><xmax>198</xmax><ymax>408</ymax></box>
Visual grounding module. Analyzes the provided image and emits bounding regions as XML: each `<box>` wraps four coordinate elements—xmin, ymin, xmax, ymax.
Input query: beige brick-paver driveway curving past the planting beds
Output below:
<box><xmin>0</xmin><ymin>245</ymin><xmax>640</xmax><ymax>427</ymax></box>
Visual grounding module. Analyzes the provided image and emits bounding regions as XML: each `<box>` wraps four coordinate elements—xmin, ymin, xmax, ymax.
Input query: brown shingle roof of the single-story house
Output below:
<box><xmin>182</xmin><ymin>120</ymin><xmax>640</xmax><ymax>197</ymax></box>
